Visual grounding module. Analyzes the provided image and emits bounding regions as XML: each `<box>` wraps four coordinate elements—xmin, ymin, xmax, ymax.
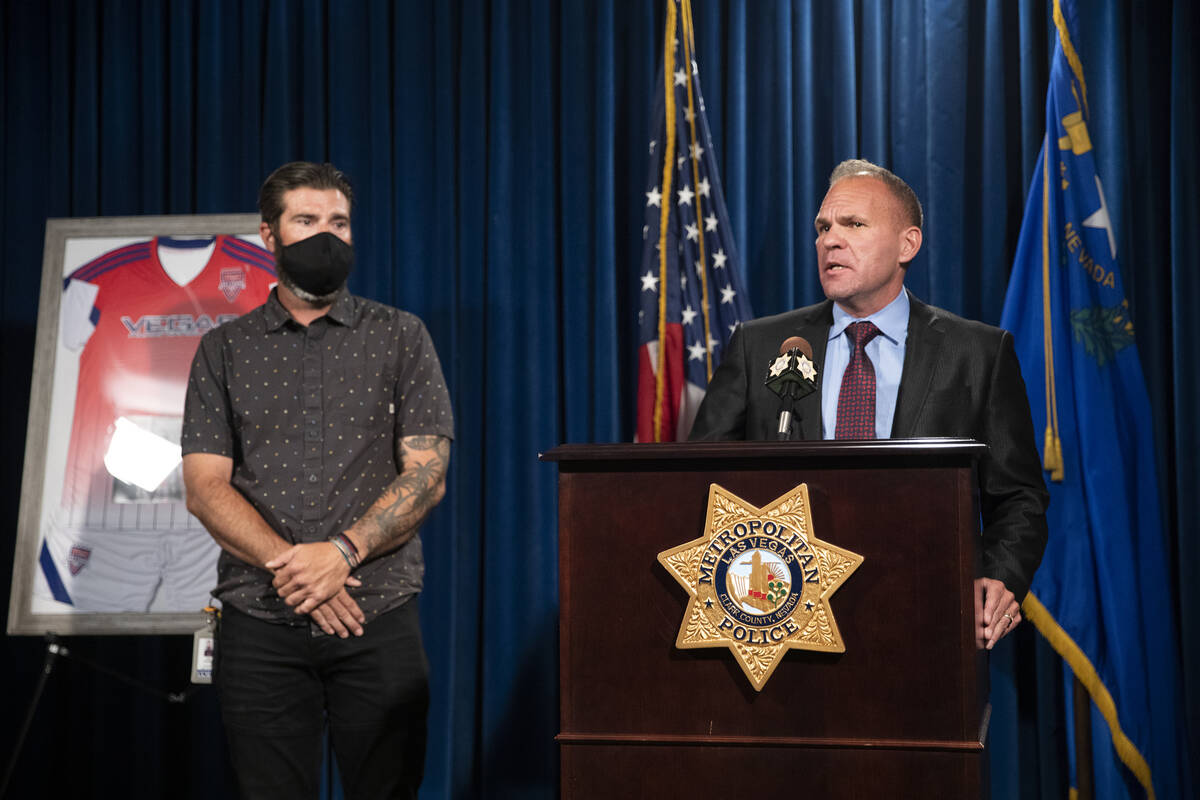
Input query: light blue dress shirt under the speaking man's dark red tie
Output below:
<box><xmin>821</xmin><ymin>289</ymin><xmax>908</xmax><ymax>439</ymax></box>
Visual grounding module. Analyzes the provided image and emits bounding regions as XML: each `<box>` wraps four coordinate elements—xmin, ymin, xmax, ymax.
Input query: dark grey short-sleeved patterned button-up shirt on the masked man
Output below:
<box><xmin>181</xmin><ymin>289</ymin><xmax>454</xmax><ymax>631</ymax></box>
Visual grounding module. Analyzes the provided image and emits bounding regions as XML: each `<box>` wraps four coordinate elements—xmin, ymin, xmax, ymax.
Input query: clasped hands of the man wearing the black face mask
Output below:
<box><xmin>265</xmin><ymin>542</ymin><xmax>366</xmax><ymax>639</ymax></box>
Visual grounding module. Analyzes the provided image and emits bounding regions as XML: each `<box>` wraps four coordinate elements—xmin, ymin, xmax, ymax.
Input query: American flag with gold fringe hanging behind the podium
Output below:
<box><xmin>637</xmin><ymin>0</ymin><xmax>751</xmax><ymax>441</ymax></box>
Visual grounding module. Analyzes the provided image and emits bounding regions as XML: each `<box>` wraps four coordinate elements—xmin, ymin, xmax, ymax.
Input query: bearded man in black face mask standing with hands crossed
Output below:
<box><xmin>182</xmin><ymin>162</ymin><xmax>452</xmax><ymax>798</ymax></box>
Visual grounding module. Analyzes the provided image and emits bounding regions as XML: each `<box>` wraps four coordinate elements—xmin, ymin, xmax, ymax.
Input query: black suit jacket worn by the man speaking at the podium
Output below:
<box><xmin>690</xmin><ymin>294</ymin><xmax>1050</xmax><ymax>600</ymax></box>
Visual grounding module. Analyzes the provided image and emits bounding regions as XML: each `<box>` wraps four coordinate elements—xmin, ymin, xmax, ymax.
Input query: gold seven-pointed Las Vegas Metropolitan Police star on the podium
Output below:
<box><xmin>659</xmin><ymin>483</ymin><xmax>863</xmax><ymax>691</ymax></box>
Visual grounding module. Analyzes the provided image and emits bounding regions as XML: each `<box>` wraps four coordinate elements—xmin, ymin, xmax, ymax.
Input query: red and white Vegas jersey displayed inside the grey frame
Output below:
<box><xmin>59</xmin><ymin>235</ymin><xmax>275</xmax><ymax>531</ymax></box>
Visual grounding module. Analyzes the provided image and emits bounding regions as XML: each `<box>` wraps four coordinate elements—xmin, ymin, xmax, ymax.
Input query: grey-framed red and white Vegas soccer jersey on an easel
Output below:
<box><xmin>8</xmin><ymin>215</ymin><xmax>275</xmax><ymax>634</ymax></box>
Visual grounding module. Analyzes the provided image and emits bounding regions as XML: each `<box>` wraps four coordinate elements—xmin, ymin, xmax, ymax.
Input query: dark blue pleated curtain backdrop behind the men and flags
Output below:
<box><xmin>0</xmin><ymin>0</ymin><xmax>1200</xmax><ymax>798</ymax></box>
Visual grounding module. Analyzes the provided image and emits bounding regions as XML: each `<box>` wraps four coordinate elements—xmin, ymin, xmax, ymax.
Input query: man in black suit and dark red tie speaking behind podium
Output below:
<box><xmin>691</xmin><ymin>160</ymin><xmax>1049</xmax><ymax>649</ymax></box>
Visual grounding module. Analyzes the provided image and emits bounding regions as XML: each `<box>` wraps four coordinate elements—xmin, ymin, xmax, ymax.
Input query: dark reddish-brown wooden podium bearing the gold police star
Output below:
<box><xmin>542</xmin><ymin>439</ymin><xmax>989</xmax><ymax>800</ymax></box>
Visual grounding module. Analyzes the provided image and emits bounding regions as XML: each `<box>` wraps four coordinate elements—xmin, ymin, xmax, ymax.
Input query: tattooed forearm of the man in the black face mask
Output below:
<box><xmin>355</xmin><ymin>435</ymin><xmax>450</xmax><ymax>555</ymax></box>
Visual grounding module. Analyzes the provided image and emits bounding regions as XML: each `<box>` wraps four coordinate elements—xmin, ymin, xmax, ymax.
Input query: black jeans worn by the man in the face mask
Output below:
<box><xmin>214</xmin><ymin>597</ymin><xmax>430</xmax><ymax>800</ymax></box>
